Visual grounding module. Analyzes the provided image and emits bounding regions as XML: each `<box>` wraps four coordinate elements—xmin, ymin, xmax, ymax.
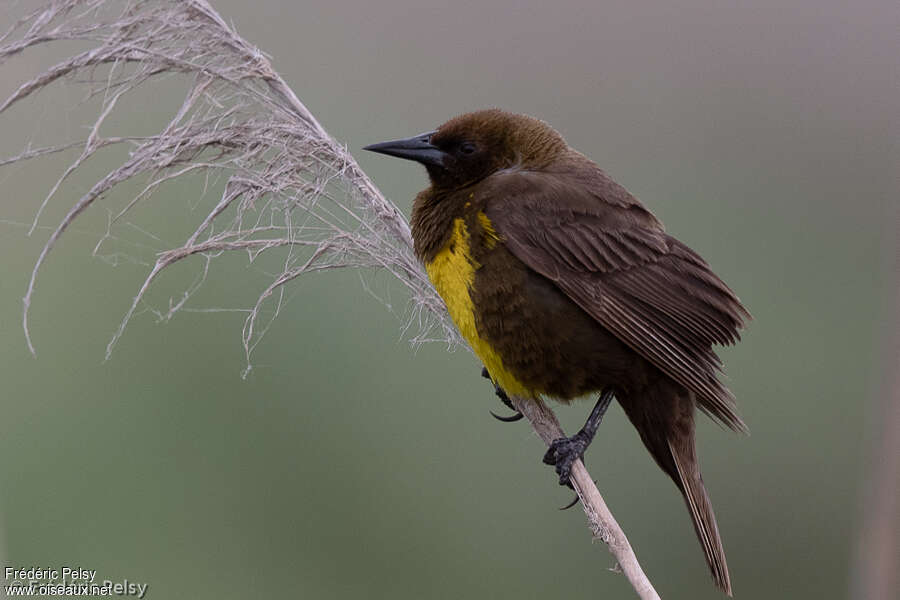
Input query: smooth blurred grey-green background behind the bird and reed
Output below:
<box><xmin>0</xmin><ymin>0</ymin><xmax>900</xmax><ymax>600</ymax></box>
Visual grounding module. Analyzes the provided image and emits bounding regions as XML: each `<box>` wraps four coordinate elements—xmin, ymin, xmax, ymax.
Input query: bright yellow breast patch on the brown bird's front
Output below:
<box><xmin>425</xmin><ymin>213</ymin><xmax>535</xmax><ymax>397</ymax></box>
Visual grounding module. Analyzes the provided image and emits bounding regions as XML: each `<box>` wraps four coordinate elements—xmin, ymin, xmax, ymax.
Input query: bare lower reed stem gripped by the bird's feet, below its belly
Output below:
<box><xmin>510</xmin><ymin>397</ymin><xmax>659</xmax><ymax>600</ymax></box>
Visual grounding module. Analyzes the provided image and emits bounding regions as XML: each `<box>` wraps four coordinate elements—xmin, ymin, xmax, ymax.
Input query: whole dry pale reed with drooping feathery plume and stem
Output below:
<box><xmin>0</xmin><ymin>0</ymin><xmax>659</xmax><ymax>599</ymax></box>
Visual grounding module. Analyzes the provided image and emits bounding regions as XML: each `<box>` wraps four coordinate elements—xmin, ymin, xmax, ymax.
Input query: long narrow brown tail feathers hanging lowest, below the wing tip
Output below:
<box><xmin>668</xmin><ymin>439</ymin><xmax>731</xmax><ymax>596</ymax></box>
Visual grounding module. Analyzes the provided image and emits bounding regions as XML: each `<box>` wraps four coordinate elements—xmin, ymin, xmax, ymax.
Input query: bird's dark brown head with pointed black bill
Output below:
<box><xmin>363</xmin><ymin>109</ymin><xmax>568</xmax><ymax>189</ymax></box>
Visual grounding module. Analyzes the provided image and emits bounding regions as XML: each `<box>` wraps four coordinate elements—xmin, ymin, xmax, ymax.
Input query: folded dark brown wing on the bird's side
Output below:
<box><xmin>480</xmin><ymin>167</ymin><xmax>750</xmax><ymax>430</ymax></box>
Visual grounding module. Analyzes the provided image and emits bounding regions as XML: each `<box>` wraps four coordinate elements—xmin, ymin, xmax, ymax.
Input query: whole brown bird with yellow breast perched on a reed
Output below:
<box><xmin>364</xmin><ymin>108</ymin><xmax>751</xmax><ymax>596</ymax></box>
